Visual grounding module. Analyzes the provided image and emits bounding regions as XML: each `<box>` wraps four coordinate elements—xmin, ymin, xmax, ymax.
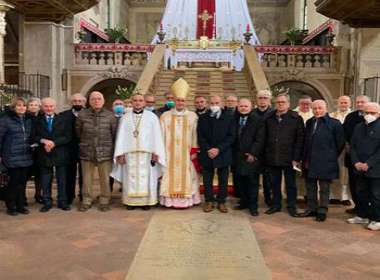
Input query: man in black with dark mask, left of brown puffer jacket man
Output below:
<box><xmin>61</xmin><ymin>93</ymin><xmax>86</xmax><ymax>205</ymax></box>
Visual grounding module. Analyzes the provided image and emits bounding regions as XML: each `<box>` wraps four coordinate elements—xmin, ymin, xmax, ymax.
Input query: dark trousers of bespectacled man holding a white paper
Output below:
<box><xmin>269</xmin><ymin>166</ymin><xmax>297</xmax><ymax>209</ymax></box>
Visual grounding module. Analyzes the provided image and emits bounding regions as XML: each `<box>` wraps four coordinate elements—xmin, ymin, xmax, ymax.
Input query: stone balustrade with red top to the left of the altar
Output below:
<box><xmin>74</xmin><ymin>43</ymin><xmax>155</xmax><ymax>66</ymax></box>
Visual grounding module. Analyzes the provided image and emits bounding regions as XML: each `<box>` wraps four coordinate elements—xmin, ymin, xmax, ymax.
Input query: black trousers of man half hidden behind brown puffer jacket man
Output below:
<box><xmin>66</xmin><ymin>159</ymin><xmax>83</xmax><ymax>204</ymax></box>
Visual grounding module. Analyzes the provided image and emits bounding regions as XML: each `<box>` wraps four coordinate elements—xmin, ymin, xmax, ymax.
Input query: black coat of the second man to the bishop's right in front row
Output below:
<box><xmin>234</xmin><ymin>113</ymin><xmax>265</xmax><ymax>176</ymax></box>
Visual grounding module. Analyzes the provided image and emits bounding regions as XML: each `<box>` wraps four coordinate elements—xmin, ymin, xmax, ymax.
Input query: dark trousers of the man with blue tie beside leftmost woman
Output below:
<box><xmin>40</xmin><ymin>166</ymin><xmax>67</xmax><ymax>207</ymax></box>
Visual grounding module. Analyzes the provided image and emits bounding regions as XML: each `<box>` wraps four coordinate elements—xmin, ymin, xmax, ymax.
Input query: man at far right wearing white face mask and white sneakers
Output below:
<box><xmin>347</xmin><ymin>102</ymin><xmax>380</xmax><ymax>230</ymax></box>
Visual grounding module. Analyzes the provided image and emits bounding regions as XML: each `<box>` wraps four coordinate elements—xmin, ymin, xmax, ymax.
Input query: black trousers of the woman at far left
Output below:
<box><xmin>5</xmin><ymin>167</ymin><xmax>29</xmax><ymax>210</ymax></box>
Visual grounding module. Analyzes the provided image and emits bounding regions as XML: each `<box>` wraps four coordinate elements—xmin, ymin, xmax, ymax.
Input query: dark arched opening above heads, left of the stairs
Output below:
<box><xmin>87</xmin><ymin>78</ymin><xmax>136</xmax><ymax>109</ymax></box>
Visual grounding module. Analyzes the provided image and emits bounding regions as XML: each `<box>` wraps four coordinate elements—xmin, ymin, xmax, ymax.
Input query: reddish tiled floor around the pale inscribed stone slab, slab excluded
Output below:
<box><xmin>0</xmin><ymin>188</ymin><xmax>380</xmax><ymax>280</ymax></box>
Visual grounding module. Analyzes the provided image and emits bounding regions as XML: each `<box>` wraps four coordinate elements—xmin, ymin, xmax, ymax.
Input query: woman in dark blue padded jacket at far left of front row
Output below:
<box><xmin>0</xmin><ymin>97</ymin><xmax>33</xmax><ymax>216</ymax></box>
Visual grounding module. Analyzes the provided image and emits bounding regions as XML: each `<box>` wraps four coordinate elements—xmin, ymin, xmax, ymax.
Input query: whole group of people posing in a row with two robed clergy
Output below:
<box><xmin>0</xmin><ymin>78</ymin><xmax>380</xmax><ymax>230</ymax></box>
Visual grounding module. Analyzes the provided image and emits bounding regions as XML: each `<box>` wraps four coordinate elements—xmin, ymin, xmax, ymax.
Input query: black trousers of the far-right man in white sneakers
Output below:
<box><xmin>356</xmin><ymin>176</ymin><xmax>380</xmax><ymax>222</ymax></box>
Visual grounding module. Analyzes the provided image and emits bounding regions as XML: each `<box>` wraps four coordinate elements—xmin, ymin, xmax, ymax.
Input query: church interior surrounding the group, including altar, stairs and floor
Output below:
<box><xmin>0</xmin><ymin>0</ymin><xmax>380</xmax><ymax>280</ymax></box>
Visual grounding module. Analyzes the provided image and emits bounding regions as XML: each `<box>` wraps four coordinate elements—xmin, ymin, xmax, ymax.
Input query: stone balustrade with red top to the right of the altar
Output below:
<box><xmin>256</xmin><ymin>46</ymin><xmax>340</xmax><ymax>70</ymax></box>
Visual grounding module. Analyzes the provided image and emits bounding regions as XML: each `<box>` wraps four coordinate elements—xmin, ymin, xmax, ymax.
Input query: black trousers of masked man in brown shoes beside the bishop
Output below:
<box><xmin>202</xmin><ymin>166</ymin><xmax>229</xmax><ymax>203</ymax></box>
